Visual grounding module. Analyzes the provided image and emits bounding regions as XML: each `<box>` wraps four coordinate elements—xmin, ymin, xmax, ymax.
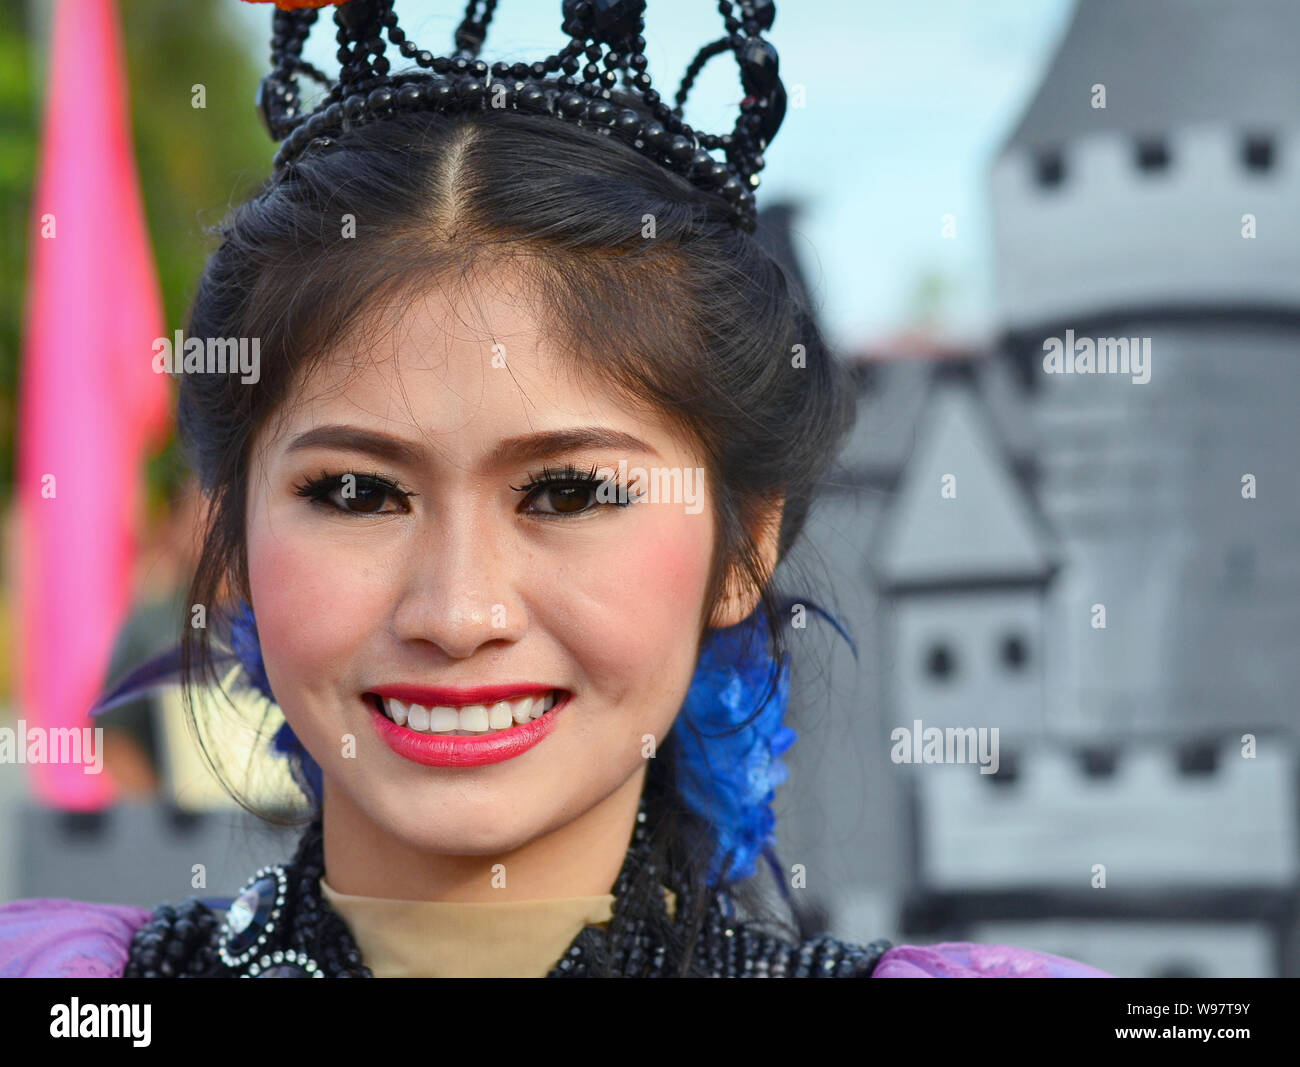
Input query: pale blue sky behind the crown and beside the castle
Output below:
<box><xmin>231</xmin><ymin>0</ymin><xmax>1073</xmax><ymax>348</ymax></box>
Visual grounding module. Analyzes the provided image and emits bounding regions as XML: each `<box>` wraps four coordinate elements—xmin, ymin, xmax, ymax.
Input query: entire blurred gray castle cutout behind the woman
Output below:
<box><xmin>777</xmin><ymin>0</ymin><xmax>1300</xmax><ymax>976</ymax></box>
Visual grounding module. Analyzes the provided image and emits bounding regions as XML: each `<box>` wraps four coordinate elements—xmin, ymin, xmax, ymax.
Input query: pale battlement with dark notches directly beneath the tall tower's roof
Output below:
<box><xmin>992</xmin><ymin>123</ymin><xmax>1300</xmax><ymax>329</ymax></box>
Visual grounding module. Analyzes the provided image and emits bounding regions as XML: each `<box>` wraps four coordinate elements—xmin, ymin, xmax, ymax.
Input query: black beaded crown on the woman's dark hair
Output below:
<box><xmin>257</xmin><ymin>0</ymin><xmax>785</xmax><ymax>233</ymax></box>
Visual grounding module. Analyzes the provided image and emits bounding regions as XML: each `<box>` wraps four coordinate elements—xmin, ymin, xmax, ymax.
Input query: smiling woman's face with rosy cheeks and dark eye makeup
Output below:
<box><xmin>247</xmin><ymin>270</ymin><xmax>738</xmax><ymax>855</ymax></box>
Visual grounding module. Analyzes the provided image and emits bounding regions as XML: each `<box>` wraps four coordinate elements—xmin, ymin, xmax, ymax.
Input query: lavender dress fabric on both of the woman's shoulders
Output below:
<box><xmin>0</xmin><ymin>897</ymin><xmax>1112</xmax><ymax>979</ymax></box>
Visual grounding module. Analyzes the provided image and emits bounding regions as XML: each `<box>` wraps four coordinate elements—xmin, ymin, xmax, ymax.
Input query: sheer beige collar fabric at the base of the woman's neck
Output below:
<box><xmin>321</xmin><ymin>879</ymin><xmax>676</xmax><ymax>979</ymax></box>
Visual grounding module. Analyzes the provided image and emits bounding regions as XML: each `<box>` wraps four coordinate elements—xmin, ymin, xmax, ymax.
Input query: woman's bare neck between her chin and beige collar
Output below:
<box><xmin>322</xmin><ymin>769</ymin><xmax>646</xmax><ymax>903</ymax></box>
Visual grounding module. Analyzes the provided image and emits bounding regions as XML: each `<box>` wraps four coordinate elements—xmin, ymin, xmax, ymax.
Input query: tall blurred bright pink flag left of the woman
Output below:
<box><xmin>16</xmin><ymin>0</ymin><xmax>170</xmax><ymax>811</ymax></box>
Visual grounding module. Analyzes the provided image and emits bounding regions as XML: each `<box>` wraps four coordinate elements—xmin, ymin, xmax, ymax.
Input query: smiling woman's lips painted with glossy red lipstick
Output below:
<box><xmin>367</xmin><ymin>685</ymin><xmax>571</xmax><ymax>767</ymax></box>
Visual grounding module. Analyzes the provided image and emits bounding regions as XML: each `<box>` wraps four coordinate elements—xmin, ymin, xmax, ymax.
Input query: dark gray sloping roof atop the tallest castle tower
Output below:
<box><xmin>1002</xmin><ymin>0</ymin><xmax>1300</xmax><ymax>153</ymax></box>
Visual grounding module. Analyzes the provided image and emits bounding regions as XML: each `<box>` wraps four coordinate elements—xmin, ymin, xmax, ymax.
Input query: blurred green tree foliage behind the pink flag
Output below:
<box><xmin>0</xmin><ymin>0</ymin><xmax>266</xmax><ymax>509</ymax></box>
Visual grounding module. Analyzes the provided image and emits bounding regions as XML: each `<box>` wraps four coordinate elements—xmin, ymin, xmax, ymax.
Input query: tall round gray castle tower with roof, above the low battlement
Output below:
<box><xmin>991</xmin><ymin>0</ymin><xmax>1300</xmax><ymax>738</ymax></box>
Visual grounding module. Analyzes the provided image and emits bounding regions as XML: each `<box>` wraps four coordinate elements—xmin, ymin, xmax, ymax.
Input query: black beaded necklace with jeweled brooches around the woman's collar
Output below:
<box><xmin>124</xmin><ymin>798</ymin><xmax>889</xmax><ymax>979</ymax></box>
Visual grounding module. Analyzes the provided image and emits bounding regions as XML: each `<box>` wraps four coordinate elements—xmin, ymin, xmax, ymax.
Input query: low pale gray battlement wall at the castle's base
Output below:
<box><xmin>906</xmin><ymin>736</ymin><xmax>1300</xmax><ymax>893</ymax></box>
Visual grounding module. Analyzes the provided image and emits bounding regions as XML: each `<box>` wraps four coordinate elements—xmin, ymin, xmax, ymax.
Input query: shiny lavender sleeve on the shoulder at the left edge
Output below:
<box><xmin>0</xmin><ymin>897</ymin><xmax>151</xmax><ymax>979</ymax></box>
